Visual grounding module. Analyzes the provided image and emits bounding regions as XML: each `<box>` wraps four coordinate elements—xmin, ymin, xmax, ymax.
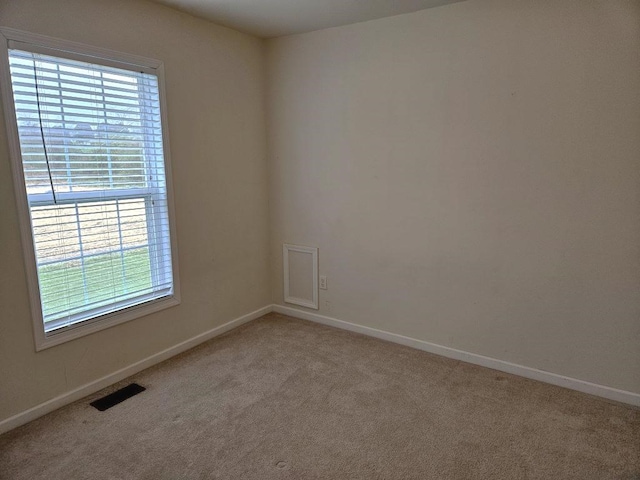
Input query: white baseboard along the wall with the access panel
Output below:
<box><xmin>273</xmin><ymin>305</ymin><xmax>640</xmax><ymax>407</ymax></box>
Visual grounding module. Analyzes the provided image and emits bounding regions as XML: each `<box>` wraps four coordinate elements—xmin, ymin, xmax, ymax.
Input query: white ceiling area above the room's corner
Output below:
<box><xmin>155</xmin><ymin>0</ymin><xmax>462</xmax><ymax>38</ymax></box>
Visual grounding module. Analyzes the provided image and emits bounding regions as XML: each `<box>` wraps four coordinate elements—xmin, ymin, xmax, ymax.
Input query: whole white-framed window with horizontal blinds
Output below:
<box><xmin>2</xmin><ymin>29</ymin><xmax>178</xmax><ymax>349</ymax></box>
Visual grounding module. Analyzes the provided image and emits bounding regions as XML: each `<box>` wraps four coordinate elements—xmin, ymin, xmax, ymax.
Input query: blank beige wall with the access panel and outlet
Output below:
<box><xmin>267</xmin><ymin>0</ymin><xmax>640</xmax><ymax>393</ymax></box>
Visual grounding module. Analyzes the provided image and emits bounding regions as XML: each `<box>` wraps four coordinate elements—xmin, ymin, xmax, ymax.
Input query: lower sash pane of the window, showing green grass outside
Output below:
<box><xmin>31</xmin><ymin>198</ymin><xmax>153</xmax><ymax>328</ymax></box>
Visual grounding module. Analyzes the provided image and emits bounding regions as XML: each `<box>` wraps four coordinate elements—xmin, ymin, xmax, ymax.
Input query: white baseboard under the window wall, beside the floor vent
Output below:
<box><xmin>0</xmin><ymin>305</ymin><xmax>272</xmax><ymax>434</ymax></box>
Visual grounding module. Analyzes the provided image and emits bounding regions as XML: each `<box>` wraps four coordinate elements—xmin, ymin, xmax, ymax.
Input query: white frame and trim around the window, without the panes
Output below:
<box><xmin>0</xmin><ymin>27</ymin><xmax>180</xmax><ymax>351</ymax></box>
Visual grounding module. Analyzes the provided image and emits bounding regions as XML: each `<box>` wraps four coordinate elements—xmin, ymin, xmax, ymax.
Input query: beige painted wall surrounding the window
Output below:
<box><xmin>0</xmin><ymin>0</ymin><xmax>271</xmax><ymax>421</ymax></box>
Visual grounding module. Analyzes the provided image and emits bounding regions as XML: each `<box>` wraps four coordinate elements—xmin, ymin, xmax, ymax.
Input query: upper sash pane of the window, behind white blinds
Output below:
<box><xmin>11</xmin><ymin>50</ymin><xmax>162</xmax><ymax>193</ymax></box>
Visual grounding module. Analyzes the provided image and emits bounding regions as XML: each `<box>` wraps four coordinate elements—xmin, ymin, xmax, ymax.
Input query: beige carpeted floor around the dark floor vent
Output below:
<box><xmin>0</xmin><ymin>314</ymin><xmax>640</xmax><ymax>480</ymax></box>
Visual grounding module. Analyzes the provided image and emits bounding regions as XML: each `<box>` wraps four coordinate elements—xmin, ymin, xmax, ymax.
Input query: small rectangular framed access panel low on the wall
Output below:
<box><xmin>282</xmin><ymin>243</ymin><xmax>318</xmax><ymax>310</ymax></box>
